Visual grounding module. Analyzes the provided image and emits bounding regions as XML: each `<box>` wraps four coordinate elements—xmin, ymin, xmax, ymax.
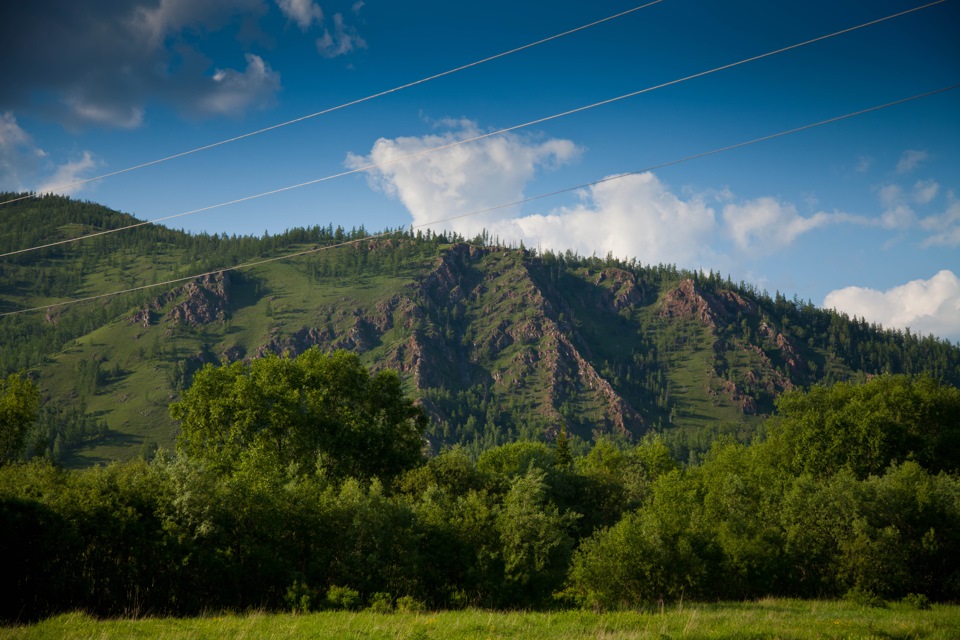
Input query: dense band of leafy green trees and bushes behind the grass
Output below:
<box><xmin>0</xmin><ymin>362</ymin><xmax>960</xmax><ymax>621</ymax></box>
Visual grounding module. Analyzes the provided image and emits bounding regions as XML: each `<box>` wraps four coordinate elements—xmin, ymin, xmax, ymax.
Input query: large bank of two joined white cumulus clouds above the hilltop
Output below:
<box><xmin>347</xmin><ymin>120</ymin><xmax>716</xmax><ymax>266</ymax></box>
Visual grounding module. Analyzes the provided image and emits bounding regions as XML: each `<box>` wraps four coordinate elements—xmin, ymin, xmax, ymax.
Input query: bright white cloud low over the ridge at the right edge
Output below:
<box><xmin>823</xmin><ymin>269</ymin><xmax>960</xmax><ymax>341</ymax></box>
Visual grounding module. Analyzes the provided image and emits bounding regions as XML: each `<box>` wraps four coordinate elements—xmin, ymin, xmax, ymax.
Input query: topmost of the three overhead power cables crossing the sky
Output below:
<box><xmin>0</xmin><ymin>0</ymin><xmax>664</xmax><ymax>206</ymax></box>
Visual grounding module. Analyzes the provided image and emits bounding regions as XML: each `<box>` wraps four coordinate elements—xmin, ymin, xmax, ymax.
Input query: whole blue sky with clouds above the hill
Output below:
<box><xmin>0</xmin><ymin>0</ymin><xmax>960</xmax><ymax>342</ymax></box>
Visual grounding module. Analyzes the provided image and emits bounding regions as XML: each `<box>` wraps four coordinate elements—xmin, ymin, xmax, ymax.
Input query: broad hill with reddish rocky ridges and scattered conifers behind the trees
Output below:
<box><xmin>0</xmin><ymin>194</ymin><xmax>960</xmax><ymax>465</ymax></box>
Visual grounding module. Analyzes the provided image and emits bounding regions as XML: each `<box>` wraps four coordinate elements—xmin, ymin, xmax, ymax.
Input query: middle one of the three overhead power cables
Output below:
<box><xmin>0</xmin><ymin>0</ymin><xmax>946</xmax><ymax>258</ymax></box>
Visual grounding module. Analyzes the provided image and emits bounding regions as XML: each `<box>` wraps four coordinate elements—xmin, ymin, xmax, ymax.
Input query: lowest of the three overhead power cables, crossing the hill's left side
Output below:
<box><xmin>0</xmin><ymin>83</ymin><xmax>960</xmax><ymax>318</ymax></box>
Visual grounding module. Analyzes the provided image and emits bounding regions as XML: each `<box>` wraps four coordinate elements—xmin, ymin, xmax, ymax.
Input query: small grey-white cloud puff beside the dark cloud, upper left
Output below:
<box><xmin>198</xmin><ymin>53</ymin><xmax>280</xmax><ymax>115</ymax></box>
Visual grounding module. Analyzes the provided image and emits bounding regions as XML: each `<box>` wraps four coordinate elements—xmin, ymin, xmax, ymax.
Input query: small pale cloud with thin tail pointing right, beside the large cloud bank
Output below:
<box><xmin>723</xmin><ymin>197</ymin><xmax>866</xmax><ymax>252</ymax></box>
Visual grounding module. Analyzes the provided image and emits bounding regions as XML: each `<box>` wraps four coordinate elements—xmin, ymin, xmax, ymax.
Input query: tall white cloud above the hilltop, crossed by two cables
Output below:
<box><xmin>346</xmin><ymin>120</ymin><xmax>579</xmax><ymax>237</ymax></box>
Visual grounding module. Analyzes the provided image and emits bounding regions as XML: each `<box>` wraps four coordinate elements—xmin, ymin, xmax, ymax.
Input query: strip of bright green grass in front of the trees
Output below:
<box><xmin>0</xmin><ymin>599</ymin><xmax>960</xmax><ymax>640</ymax></box>
